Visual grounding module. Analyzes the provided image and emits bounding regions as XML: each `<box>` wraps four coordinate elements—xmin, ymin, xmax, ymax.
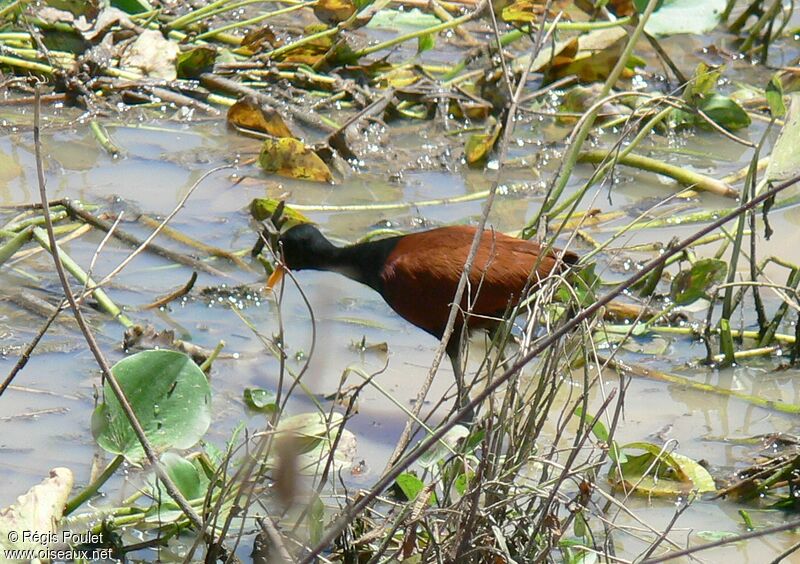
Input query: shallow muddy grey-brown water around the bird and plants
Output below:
<box><xmin>0</xmin><ymin>34</ymin><xmax>800</xmax><ymax>562</ymax></box>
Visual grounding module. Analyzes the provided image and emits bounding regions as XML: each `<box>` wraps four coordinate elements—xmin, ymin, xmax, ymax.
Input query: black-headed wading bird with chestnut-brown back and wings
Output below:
<box><xmin>267</xmin><ymin>223</ymin><xmax>578</xmax><ymax>403</ymax></box>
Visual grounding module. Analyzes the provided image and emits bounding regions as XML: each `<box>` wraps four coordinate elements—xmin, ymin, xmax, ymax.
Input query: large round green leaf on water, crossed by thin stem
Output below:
<box><xmin>92</xmin><ymin>350</ymin><xmax>211</xmax><ymax>464</ymax></box>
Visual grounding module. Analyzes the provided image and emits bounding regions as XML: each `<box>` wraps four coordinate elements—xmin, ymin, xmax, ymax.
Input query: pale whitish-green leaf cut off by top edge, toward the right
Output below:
<box><xmin>636</xmin><ymin>0</ymin><xmax>727</xmax><ymax>35</ymax></box>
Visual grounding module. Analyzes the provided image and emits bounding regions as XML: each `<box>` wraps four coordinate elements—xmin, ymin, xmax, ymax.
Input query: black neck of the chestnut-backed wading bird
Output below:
<box><xmin>320</xmin><ymin>237</ymin><xmax>397</xmax><ymax>292</ymax></box>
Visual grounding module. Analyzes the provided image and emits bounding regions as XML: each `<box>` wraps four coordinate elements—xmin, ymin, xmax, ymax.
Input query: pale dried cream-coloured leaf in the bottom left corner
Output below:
<box><xmin>0</xmin><ymin>468</ymin><xmax>73</xmax><ymax>562</ymax></box>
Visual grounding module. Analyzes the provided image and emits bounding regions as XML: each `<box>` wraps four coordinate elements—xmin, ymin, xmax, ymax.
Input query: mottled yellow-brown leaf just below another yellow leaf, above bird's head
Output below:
<box><xmin>258</xmin><ymin>137</ymin><xmax>333</xmax><ymax>182</ymax></box>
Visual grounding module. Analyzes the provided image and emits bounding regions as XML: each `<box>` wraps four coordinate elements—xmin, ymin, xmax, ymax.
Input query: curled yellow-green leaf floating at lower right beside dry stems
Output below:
<box><xmin>608</xmin><ymin>442</ymin><xmax>716</xmax><ymax>496</ymax></box>
